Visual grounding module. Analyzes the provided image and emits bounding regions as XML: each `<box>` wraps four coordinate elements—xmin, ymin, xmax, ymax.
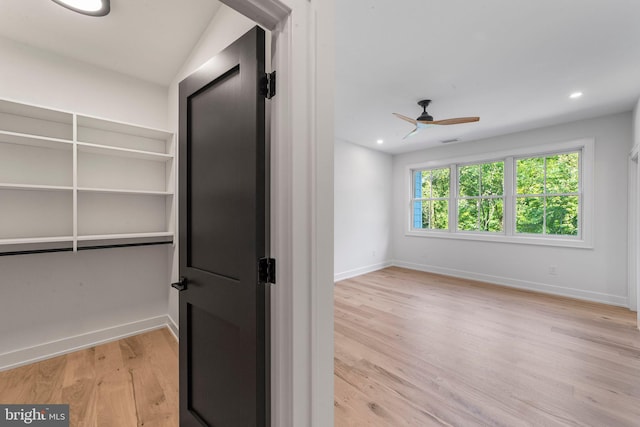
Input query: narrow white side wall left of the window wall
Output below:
<box><xmin>334</xmin><ymin>140</ymin><xmax>393</xmax><ymax>281</ymax></box>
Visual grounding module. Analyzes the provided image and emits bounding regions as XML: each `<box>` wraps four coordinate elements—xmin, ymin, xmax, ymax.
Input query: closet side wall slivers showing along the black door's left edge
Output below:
<box><xmin>167</xmin><ymin>4</ymin><xmax>256</xmax><ymax>331</ymax></box>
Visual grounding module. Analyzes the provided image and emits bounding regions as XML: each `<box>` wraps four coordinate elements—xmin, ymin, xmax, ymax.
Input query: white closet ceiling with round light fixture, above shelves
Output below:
<box><xmin>0</xmin><ymin>0</ymin><xmax>220</xmax><ymax>86</ymax></box>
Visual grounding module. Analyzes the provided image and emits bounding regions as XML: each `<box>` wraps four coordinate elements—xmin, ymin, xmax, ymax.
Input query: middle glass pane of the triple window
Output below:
<box><xmin>458</xmin><ymin>161</ymin><xmax>504</xmax><ymax>232</ymax></box>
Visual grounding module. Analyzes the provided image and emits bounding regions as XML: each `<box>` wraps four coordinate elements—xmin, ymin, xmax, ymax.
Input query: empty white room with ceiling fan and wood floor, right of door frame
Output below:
<box><xmin>334</xmin><ymin>0</ymin><xmax>640</xmax><ymax>426</ymax></box>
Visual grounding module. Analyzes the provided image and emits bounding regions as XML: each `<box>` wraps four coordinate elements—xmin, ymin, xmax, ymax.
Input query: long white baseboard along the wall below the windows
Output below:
<box><xmin>392</xmin><ymin>260</ymin><xmax>629</xmax><ymax>308</ymax></box>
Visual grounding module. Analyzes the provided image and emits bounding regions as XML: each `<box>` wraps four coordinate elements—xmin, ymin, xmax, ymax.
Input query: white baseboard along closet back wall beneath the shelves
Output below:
<box><xmin>0</xmin><ymin>316</ymin><xmax>173</xmax><ymax>371</ymax></box>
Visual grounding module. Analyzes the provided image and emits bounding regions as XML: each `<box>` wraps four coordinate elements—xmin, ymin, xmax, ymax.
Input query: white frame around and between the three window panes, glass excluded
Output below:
<box><xmin>404</xmin><ymin>138</ymin><xmax>595</xmax><ymax>249</ymax></box>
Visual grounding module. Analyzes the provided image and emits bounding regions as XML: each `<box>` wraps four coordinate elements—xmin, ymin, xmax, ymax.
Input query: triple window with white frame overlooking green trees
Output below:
<box><xmin>407</xmin><ymin>139</ymin><xmax>594</xmax><ymax>247</ymax></box>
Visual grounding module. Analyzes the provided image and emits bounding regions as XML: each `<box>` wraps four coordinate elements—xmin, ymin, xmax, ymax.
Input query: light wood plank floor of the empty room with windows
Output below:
<box><xmin>334</xmin><ymin>267</ymin><xmax>640</xmax><ymax>427</ymax></box>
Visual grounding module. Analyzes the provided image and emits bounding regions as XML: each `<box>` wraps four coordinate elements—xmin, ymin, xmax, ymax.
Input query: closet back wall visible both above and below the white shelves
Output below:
<box><xmin>0</xmin><ymin>39</ymin><xmax>168</xmax><ymax>368</ymax></box>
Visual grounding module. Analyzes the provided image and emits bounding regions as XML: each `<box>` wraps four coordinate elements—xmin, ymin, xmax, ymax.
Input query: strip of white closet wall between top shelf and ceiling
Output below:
<box><xmin>0</xmin><ymin>38</ymin><xmax>167</xmax><ymax>129</ymax></box>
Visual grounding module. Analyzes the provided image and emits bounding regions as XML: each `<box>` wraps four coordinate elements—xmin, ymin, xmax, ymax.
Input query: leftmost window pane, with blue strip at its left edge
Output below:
<box><xmin>412</xmin><ymin>168</ymin><xmax>450</xmax><ymax>230</ymax></box>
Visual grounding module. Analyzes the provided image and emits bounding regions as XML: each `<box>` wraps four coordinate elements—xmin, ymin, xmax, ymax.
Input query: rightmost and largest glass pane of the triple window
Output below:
<box><xmin>516</xmin><ymin>152</ymin><xmax>580</xmax><ymax>236</ymax></box>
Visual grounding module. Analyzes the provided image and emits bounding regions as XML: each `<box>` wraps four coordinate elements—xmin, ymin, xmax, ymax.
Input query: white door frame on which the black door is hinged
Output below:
<box><xmin>221</xmin><ymin>0</ymin><xmax>334</xmax><ymax>427</ymax></box>
